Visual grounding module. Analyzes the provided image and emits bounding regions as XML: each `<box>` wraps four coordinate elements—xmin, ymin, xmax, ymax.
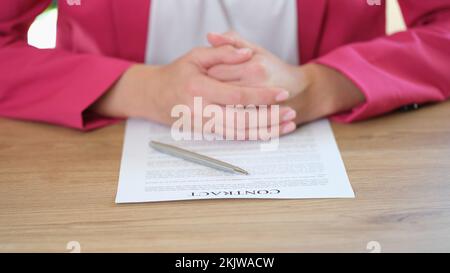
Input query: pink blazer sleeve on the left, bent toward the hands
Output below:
<box><xmin>0</xmin><ymin>0</ymin><xmax>131</xmax><ymax>130</ymax></box>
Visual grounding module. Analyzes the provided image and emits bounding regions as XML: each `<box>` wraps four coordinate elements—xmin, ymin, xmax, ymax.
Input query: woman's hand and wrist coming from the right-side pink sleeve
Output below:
<box><xmin>208</xmin><ymin>32</ymin><xmax>365</xmax><ymax>124</ymax></box>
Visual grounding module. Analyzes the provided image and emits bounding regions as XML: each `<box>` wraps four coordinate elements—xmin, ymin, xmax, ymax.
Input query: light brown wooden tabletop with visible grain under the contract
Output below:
<box><xmin>0</xmin><ymin>103</ymin><xmax>450</xmax><ymax>252</ymax></box>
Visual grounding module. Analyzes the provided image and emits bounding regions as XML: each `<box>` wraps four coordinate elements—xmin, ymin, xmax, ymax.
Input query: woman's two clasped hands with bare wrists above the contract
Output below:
<box><xmin>93</xmin><ymin>32</ymin><xmax>364</xmax><ymax>138</ymax></box>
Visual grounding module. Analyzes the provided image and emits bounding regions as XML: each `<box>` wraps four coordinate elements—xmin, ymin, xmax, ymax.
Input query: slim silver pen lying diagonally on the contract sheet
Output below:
<box><xmin>149</xmin><ymin>140</ymin><xmax>248</xmax><ymax>175</ymax></box>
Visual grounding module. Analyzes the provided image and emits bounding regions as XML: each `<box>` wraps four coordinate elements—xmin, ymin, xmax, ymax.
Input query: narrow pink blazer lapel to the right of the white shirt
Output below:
<box><xmin>297</xmin><ymin>0</ymin><xmax>328</xmax><ymax>64</ymax></box>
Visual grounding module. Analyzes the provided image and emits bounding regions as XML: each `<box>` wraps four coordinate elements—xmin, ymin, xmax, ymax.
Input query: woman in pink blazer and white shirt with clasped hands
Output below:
<box><xmin>0</xmin><ymin>0</ymin><xmax>450</xmax><ymax>134</ymax></box>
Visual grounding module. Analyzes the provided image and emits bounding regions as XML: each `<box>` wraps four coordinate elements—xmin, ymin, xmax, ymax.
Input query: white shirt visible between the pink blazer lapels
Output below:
<box><xmin>146</xmin><ymin>0</ymin><xmax>299</xmax><ymax>65</ymax></box>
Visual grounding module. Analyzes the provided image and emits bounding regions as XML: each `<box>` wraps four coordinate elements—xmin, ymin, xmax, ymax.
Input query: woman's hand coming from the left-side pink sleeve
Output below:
<box><xmin>93</xmin><ymin>46</ymin><xmax>295</xmax><ymax>136</ymax></box>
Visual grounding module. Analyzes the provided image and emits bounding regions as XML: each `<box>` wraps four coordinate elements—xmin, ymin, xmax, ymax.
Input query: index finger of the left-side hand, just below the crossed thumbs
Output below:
<box><xmin>188</xmin><ymin>76</ymin><xmax>289</xmax><ymax>106</ymax></box>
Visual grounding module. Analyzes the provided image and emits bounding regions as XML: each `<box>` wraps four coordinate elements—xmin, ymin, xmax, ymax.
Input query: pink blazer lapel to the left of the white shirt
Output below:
<box><xmin>111</xmin><ymin>0</ymin><xmax>150</xmax><ymax>63</ymax></box>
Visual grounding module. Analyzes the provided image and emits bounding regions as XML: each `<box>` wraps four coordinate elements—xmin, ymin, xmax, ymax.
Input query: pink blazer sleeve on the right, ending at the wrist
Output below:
<box><xmin>315</xmin><ymin>0</ymin><xmax>450</xmax><ymax>122</ymax></box>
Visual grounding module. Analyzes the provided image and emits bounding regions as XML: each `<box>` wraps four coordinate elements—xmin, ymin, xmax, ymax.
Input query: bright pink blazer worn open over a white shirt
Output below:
<box><xmin>0</xmin><ymin>0</ymin><xmax>450</xmax><ymax>130</ymax></box>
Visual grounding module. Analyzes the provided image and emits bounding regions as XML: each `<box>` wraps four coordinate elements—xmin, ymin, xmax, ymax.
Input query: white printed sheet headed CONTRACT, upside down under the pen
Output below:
<box><xmin>116</xmin><ymin>119</ymin><xmax>355</xmax><ymax>203</ymax></box>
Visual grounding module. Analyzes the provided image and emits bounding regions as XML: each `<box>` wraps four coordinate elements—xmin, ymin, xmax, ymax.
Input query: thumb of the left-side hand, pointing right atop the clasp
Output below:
<box><xmin>191</xmin><ymin>45</ymin><xmax>253</xmax><ymax>69</ymax></box>
